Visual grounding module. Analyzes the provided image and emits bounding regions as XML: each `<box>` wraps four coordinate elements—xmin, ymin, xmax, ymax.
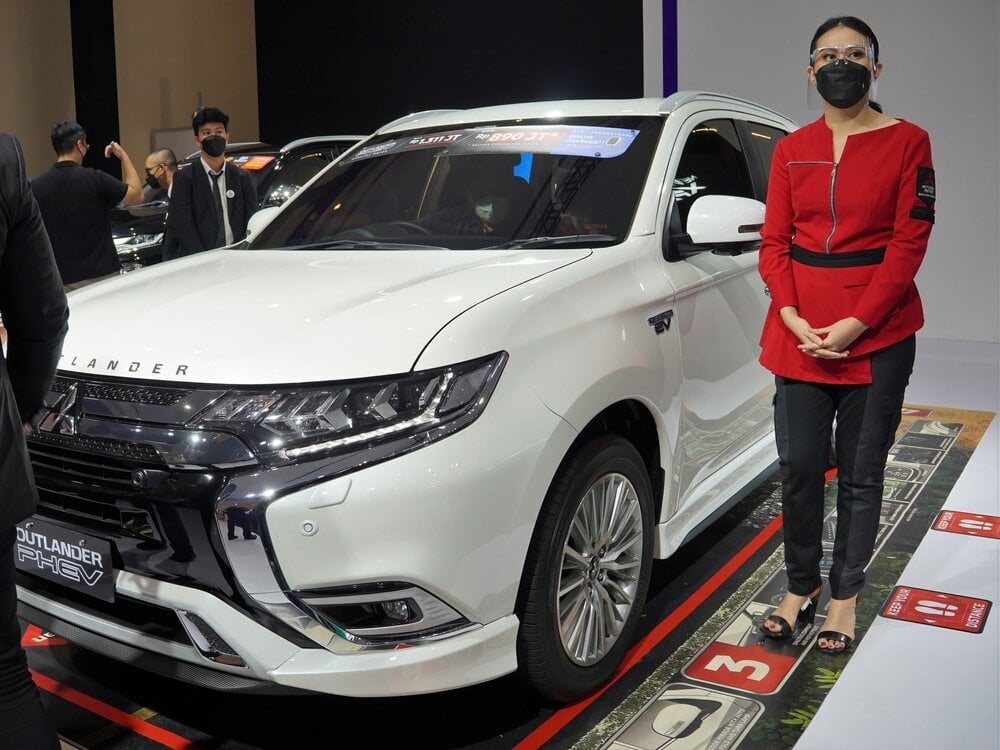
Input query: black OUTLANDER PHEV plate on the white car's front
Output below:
<box><xmin>14</xmin><ymin>517</ymin><xmax>115</xmax><ymax>602</ymax></box>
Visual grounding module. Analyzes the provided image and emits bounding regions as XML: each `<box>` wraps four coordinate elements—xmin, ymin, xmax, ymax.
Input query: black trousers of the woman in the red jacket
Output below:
<box><xmin>774</xmin><ymin>336</ymin><xmax>916</xmax><ymax>599</ymax></box>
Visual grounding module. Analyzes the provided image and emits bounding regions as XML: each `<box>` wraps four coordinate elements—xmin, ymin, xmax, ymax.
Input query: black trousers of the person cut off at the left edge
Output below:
<box><xmin>0</xmin><ymin>528</ymin><xmax>59</xmax><ymax>750</ymax></box>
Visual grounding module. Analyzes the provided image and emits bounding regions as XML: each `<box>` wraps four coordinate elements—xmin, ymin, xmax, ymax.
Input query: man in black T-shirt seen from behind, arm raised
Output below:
<box><xmin>31</xmin><ymin>120</ymin><xmax>143</xmax><ymax>291</ymax></box>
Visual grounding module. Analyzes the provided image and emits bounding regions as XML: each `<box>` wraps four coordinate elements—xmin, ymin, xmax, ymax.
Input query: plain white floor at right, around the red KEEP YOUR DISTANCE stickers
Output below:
<box><xmin>795</xmin><ymin>336</ymin><xmax>1000</xmax><ymax>750</ymax></box>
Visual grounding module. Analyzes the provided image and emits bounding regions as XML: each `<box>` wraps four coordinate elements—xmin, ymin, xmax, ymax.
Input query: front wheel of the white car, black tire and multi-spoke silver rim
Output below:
<box><xmin>517</xmin><ymin>435</ymin><xmax>653</xmax><ymax>703</ymax></box>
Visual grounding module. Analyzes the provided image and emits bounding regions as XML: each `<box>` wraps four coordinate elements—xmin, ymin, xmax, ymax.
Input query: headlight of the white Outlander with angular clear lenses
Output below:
<box><xmin>188</xmin><ymin>352</ymin><xmax>507</xmax><ymax>465</ymax></box>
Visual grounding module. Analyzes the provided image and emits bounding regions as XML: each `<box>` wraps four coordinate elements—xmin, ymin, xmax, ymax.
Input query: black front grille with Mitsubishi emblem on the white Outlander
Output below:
<box><xmin>28</xmin><ymin>373</ymin><xmax>242</xmax><ymax>541</ymax></box>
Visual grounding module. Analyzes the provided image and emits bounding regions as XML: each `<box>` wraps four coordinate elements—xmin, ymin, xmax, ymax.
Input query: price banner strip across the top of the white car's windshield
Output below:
<box><xmin>349</xmin><ymin>125</ymin><xmax>639</xmax><ymax>162</ymax></box>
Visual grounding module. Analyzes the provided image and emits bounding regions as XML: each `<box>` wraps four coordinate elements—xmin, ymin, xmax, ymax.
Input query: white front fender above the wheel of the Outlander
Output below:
<box><xmin>416</xmin><ymin>236</ymin><xmax>682</xmax><ymax>520</ymax></box>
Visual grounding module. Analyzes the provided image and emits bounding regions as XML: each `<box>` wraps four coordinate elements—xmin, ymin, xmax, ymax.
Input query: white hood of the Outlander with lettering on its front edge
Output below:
<box><xmin>59</xmin><ymin>249</ymin><xmax>591</xmax><ymax>385</ymax></box>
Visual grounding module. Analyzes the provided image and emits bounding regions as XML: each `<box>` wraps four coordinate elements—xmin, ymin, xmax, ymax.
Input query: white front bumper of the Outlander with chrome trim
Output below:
<box><xmin>19</xmin><ymin>367</ymin><xmax>575</xmax><ymax>697</ymax></box>
